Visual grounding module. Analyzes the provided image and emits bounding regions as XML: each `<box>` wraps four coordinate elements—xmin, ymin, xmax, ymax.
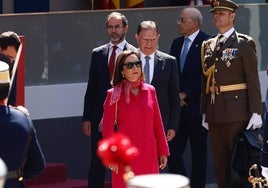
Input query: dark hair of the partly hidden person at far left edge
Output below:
<box><xmin>0</xmin><ymin>31</ymin><xmax>21</xmax><ymax>51</ymax></box>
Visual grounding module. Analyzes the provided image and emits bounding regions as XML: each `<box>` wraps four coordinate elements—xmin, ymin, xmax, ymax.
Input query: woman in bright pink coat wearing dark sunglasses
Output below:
<box><xmin>102</xmin><ymin>51</ymin><xmax>169</xmax><ymax>188</ymax></box>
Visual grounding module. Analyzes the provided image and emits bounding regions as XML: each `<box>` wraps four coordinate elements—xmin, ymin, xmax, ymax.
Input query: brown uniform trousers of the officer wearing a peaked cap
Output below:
<box><xmin>209</xmin><ymin>122</ymin><xmax>249</xmax><ymax>188</ymax></box>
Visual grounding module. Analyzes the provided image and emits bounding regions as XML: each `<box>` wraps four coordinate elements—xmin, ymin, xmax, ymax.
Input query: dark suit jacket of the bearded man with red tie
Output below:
<box><xmin>83</xmin><ymin>43</ymin><xmax>136</xmax><ymax>131</ymax></box>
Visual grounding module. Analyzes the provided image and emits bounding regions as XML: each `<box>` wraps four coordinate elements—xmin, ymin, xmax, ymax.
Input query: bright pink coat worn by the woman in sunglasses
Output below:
<box><xmin>103</xmin><ymin>83</ymin><xmax>169</xmax><ymax>188</ymax></box>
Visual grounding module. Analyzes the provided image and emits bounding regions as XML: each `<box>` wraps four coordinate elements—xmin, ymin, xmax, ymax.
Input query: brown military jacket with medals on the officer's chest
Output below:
<box><xmin>202</xmin><ymin>31</ymin><xmax>262</xmax><ymax>123</ymax></box>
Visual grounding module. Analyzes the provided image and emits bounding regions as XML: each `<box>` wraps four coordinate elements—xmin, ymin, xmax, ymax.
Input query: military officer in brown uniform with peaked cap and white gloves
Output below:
<box><xmin>201</xmin><ymin>0</ymin><xmax>262</xmax><ymax>188</ymax></box>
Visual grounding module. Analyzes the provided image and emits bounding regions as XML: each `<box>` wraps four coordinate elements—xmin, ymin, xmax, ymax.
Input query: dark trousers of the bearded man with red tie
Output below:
<box><xmin>88</xmin><ymin>131</ymin><xmax>105</xmax><ymax>188</ymax></box>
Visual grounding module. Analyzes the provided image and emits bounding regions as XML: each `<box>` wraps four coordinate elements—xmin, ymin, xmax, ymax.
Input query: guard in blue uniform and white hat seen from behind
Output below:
<box><xmin>0</xmin><ymin>61</ymin><xmax>45</xmax><ymax>188</ymax></box>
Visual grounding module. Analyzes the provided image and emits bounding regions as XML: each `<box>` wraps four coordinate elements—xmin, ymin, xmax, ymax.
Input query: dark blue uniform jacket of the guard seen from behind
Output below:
<box><xmin>0</xmin><ymin>105</ymin><xmax>45</xmax><ymax>188</ymax></box>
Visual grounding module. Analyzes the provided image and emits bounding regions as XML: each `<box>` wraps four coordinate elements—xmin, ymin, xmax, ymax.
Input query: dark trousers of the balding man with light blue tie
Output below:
<box><xmin>168</xmin><ymin>116</ymin><xmax>207</xmax><ymax>188</ymax></box>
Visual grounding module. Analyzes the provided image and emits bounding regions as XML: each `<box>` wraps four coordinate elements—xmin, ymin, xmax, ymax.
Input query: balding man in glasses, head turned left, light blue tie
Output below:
<box><xmin>169</xmin><ymin>7</ymin><xmax>208</xmax><ymax>188</ymax></box>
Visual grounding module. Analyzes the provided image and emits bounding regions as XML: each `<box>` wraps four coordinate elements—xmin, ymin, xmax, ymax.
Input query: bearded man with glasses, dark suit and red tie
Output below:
<box><xmin>82</xmin><ymin>12</ymin><xmax>136</xmax><ymax>188</ymax></box>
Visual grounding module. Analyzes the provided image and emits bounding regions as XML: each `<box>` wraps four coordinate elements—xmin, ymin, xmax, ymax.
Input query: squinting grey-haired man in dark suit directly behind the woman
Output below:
<box><xmin>135</xmin><ymin>21</ymin><xmax>180</xmax><ymax>168</ymax></box>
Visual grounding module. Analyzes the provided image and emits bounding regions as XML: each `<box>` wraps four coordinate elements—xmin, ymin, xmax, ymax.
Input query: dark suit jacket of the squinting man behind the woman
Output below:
<box><xmin>151</xmin><ymin>50</ymin><xmax>180</xmax><ymax>131</ymax></box>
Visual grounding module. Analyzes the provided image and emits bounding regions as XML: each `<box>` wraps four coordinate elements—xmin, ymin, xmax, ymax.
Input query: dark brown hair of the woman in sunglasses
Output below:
<box><xmin>112</xmin><ymin>50</ymin><xmax>144</xmax><ymax>86</ymax></box>
